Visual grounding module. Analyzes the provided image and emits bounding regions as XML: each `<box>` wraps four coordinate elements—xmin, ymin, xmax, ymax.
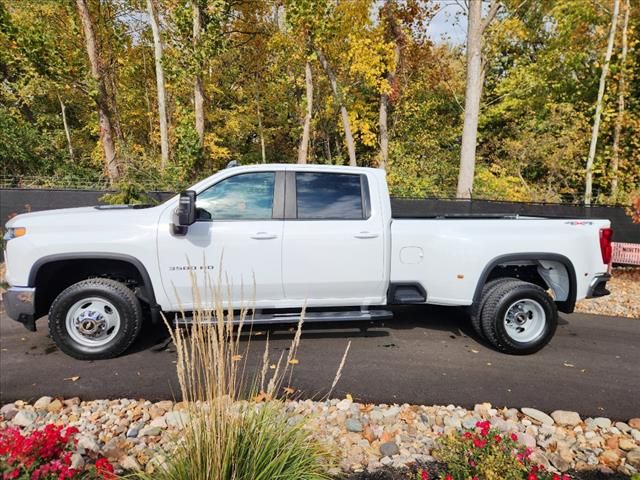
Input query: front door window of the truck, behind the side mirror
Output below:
<box><xmin>196</xmin><ymin>172</ymin><xmax>275</xmax><ymax>220</ymax></box>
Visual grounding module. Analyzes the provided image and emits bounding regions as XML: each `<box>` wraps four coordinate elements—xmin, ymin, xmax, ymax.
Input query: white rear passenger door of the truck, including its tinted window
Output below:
<box><xmin>282</xmin><ymin>170</ymin><xmax>385</xmax><ymax>306</ymax></box>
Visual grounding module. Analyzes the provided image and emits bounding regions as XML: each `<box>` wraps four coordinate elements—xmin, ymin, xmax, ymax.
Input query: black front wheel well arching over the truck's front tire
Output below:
<box><xmin>30</xmin><ymin>257</ymin><xmax>151</xmax><ymax>318</ymax></box>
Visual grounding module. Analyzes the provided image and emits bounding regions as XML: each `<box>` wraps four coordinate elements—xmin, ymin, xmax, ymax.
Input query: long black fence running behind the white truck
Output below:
<box><xmin>0</xmin><ymin>188</ymin><xmax>640</xmax><ymax>244</ymax></box>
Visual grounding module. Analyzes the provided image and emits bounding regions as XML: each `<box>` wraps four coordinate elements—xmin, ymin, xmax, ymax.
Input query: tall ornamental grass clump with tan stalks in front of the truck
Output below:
<box><xmin>140</xmin><ymin>270</ymin><xmax>348</xmax><ymax>480</ymax></box>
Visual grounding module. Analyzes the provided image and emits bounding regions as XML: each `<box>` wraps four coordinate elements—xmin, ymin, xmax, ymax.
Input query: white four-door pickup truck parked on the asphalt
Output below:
<box><xmin>3</xmin><ymin>164</ymin><xmax>612</xmax><ymax>359</ymax></box>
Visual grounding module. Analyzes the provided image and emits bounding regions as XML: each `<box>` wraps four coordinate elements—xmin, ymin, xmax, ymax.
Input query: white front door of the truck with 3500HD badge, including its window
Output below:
<box><xmin>158</xmin><ymin>171</ymin><xmax>284</xmax><ymax>311</ymax></box>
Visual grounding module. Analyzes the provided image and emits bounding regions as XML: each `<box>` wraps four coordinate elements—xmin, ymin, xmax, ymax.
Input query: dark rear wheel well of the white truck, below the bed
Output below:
<box><xmin>473</xmin><ymin>253</ymin><xmax>576</xmax><ymax>313</ymax></box>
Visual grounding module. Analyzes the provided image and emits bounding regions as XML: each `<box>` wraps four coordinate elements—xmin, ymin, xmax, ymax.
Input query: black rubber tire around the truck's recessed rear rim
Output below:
<box><xmin>480</xmin><ymin>279</ymin><xmax>558</xmax><ymax>355</ymax></box>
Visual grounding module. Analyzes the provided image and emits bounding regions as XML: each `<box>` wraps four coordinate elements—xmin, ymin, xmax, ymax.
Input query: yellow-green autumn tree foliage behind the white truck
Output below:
<box><xmin>0</xmin><ymin>0</ymin><xmax>640</xmax><ymax>202</ymax></box>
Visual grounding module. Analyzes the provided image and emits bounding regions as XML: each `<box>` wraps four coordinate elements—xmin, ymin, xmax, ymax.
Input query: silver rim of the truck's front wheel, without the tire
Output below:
<box><xmin>66</xmin><ymin>297</ymin><xmax>121</xmax><ymax>347</ymax></box>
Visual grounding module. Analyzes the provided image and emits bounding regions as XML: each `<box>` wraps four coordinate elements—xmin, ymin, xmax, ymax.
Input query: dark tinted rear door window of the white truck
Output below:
<box><xmin>296</xmin><ymin>172</ymin><xmax>364</xmax><ymax>220</ymax></box>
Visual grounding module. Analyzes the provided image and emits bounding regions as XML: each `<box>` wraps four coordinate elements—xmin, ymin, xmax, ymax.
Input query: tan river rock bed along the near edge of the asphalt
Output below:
<box><xmin>0</xmin><ymin>398</ymin><xmax>640</xmax><ymax>478</ymax></box>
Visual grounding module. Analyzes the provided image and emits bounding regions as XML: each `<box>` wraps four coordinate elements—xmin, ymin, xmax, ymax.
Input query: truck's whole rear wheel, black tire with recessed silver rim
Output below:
<box><xmin>480</xmin><ymin>279</ymin><xmax>558</xmax><ymax>355</ymax></box>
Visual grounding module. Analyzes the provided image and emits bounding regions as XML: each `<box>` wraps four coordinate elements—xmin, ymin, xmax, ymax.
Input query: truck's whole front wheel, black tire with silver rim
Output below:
<box><xmin>49</xmin><ymin>278</ymin><xmax>143</xmax><ymax>360</ymax></box>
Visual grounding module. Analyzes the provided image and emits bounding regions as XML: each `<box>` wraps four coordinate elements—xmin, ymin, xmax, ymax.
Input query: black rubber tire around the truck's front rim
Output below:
<box><xmin>49</xmin><ymin>278</ymin><xmax>143</xmax><ymax>360</ymax></box>
